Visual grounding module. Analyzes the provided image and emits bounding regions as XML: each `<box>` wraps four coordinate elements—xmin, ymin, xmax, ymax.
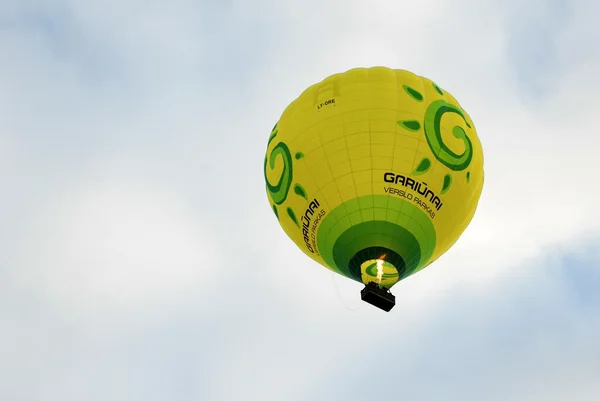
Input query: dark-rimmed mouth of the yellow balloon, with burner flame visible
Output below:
<box><xmin>349</xmin><ymin>247</ymin><xmax>404</xmax><ymax>289</ymax></box>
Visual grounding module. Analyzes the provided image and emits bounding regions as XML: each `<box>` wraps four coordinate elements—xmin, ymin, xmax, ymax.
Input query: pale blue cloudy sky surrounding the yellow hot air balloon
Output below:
<box><xmin>0</xmin><ymin>0</ymin><xmax>600</xmax><ymax>401</ymax></box>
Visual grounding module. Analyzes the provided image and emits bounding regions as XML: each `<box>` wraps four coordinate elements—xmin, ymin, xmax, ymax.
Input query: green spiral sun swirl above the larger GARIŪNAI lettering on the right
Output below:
<box><xmin>423</xmin><ymin>99</ymin><xmax>473</xmax><ymax>171</ymax></box>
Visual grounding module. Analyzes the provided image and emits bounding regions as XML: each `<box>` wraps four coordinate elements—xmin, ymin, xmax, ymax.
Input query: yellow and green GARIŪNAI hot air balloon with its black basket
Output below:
<box><xmin>264</xmin><ymin>67</ymin><xmax>484</xmax><ymax>311</ymax></box>
